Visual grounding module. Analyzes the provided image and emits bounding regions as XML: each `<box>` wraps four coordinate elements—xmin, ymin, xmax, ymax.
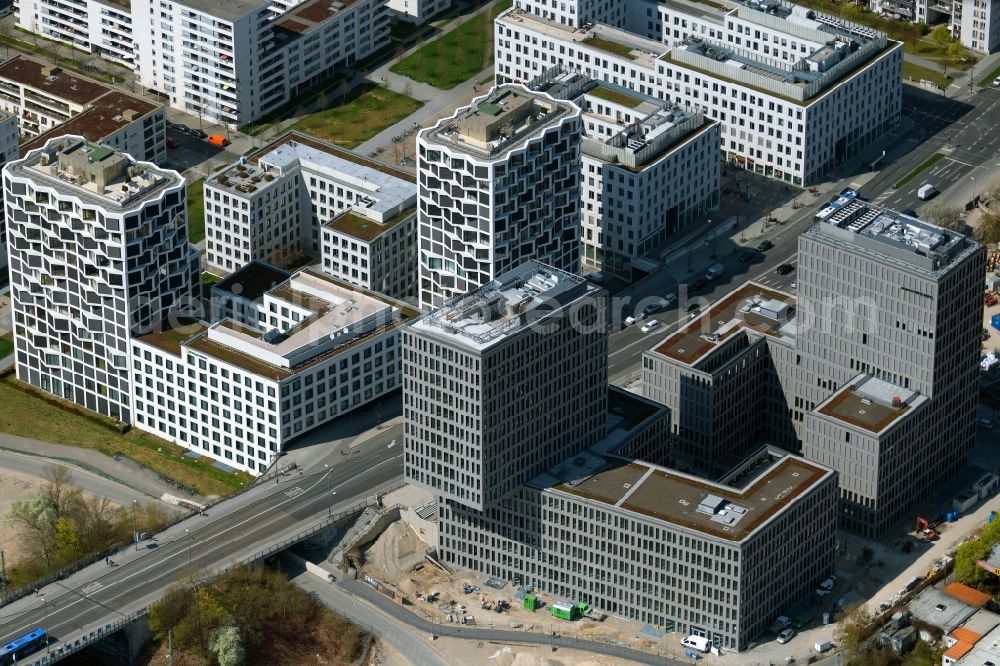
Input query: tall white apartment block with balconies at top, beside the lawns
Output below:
<box><xmin>132</xmin><ymin>0</ymin><xmax>388</xmax><ymax>128</ymax></box>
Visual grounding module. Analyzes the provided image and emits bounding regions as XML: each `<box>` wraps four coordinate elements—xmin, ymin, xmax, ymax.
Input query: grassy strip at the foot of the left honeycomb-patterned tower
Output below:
<box><xmin>0</xmin><ymin>375</ymin><xmax>251</xmax><ymax>496</ymax></box>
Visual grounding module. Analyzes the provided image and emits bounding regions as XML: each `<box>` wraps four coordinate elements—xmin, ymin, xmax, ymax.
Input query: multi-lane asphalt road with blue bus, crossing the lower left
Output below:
<box><xmin>0</xmin><ymin>431</ymin><xmax>402</xmax><ymax>643</ymax></box>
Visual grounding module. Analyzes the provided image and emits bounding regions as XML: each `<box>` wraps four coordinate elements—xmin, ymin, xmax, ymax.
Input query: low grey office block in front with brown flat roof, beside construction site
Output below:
<box><xmin>438</xmin><ymin>440</ymin><xmax>837</xmax><ymax>650</ymax></box>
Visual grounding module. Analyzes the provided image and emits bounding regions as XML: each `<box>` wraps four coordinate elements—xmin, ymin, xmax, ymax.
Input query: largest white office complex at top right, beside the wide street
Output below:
<box><xmin>496</xmin><ymin>0</ymin><xmax>902</xmax><ymax>185</ymax></box>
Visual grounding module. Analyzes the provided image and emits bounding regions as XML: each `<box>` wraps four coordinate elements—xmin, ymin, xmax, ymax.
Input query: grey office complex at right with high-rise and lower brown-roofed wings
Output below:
<box><xmin>643</xmin><ymin>195</ymin><xmax>985</xmax><ymax>538</ymax></box>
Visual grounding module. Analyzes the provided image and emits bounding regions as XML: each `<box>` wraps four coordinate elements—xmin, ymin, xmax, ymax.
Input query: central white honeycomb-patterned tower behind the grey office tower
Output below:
<box><xmin>417</xmin><ymin>85</ymin><xmax>581</xmax><ymax>309</ymax></box>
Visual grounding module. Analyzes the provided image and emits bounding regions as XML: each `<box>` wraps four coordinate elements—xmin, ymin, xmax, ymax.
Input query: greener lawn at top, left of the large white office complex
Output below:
<box><xmin>389</xmin><ymin>0</ymin><xmax>513</xmax><ymax>90</ymax></box>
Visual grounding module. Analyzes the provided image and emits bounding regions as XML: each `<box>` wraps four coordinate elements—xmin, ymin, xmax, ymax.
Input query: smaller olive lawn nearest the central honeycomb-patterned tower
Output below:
<box><xmin>291</xmin><ymin>86</ymin><xmax>423</xmax><ymax>148</ymax></box>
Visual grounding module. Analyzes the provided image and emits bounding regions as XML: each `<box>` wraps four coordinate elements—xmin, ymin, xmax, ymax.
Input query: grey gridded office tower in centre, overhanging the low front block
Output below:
<box><xmin>403</xmin><ymin>261</ymin><xmax>608</xmax><ymax>511</ymax></box>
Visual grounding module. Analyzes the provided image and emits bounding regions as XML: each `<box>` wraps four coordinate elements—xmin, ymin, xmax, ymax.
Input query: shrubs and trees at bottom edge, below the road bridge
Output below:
<box><xmin>149</xmin><ymin>567</ymin><xmax>369</xmax><ymax>666</ymax></box>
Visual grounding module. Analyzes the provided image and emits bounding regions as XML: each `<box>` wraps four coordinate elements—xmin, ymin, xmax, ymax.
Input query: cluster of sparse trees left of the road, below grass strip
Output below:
<box><xmin>4</xmin><ymin>465</ymin><xmax>173</xmax><ymax>587</ymax></box>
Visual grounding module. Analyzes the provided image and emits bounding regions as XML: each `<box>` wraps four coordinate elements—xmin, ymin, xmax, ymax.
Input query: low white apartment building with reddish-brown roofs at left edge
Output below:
<box><xmin>0</xmin><ymin>56</ymin><xmax>167</xmax><ymax>163</ymax></box>
